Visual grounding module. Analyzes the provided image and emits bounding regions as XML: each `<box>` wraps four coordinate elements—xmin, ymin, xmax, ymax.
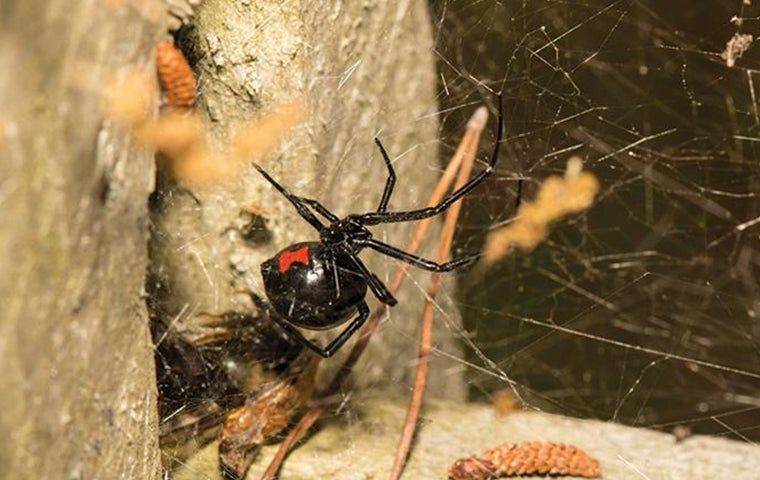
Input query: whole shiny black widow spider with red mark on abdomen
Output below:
<box><xmin>254</xmin><ymin>94</ymin><xmax>504</xmax><ymax>358</ymax></box>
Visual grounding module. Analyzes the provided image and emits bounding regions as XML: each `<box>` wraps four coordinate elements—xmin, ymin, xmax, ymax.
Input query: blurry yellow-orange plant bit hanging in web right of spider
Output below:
<box><xmin>483</xmin><ymin>157</ymin><xmax>599</xmax><ymax>263</ymax></box>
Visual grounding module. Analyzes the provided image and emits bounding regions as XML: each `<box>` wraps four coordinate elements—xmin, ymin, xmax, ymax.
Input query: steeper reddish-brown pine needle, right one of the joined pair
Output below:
<box><xmin>390</xmin><ymin>107</ymin><xmax>488</xmax><ymax>480</ymax></box>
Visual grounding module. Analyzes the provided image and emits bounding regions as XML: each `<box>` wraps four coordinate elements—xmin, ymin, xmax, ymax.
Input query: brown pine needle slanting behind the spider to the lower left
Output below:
<box><xmin>261</xmin><ymin>110</ymin><xmax>485</xmax><ymax>480</ymax></box>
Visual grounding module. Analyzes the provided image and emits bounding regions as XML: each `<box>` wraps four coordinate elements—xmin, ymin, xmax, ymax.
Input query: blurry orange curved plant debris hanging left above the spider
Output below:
<box><xmin>106</xmin><ymin>72</ymin><xmax>304</xmax><ymax>187</ymax></box>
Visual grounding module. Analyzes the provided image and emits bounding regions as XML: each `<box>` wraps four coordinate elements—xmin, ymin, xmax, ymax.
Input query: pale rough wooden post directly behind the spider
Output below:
<box><xmin>152</xmin><ymin>0</ymin><xmax>464</xmax><ymax>397</ymax></box>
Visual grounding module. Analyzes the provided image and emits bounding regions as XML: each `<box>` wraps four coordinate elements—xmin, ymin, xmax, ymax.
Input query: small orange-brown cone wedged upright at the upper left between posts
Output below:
<box><xmin>156</xmin><ymin>41</ymin><xmax>196</xmax><ymax>110</ymax></box>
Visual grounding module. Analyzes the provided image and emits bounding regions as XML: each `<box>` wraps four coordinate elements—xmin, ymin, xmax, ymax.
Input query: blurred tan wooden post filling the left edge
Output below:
<box><xmin>0</xmin><ymin>0</ymin><xmax>162</xmax><ymax>479</ymax></box>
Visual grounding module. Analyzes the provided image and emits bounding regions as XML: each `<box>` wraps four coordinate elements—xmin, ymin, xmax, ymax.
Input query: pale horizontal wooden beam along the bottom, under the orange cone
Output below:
<box><xmin>175</xmin><ymin>398</ymin><xmax>760</xmax><ymax>480</ymax></box>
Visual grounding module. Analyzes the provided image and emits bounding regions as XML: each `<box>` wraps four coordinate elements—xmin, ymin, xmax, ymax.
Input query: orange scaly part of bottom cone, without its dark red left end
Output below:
<box><xmin>483</xmin><ymin>442</ymin><xmax>601</xmax><ymax>478</ymax></box>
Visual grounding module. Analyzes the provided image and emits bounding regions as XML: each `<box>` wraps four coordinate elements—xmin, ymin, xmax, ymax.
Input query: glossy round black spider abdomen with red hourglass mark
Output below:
<box><xmin>261</xmin><ymin>242</ymin><xmax>367</xmax><ymax>330</ymax></box>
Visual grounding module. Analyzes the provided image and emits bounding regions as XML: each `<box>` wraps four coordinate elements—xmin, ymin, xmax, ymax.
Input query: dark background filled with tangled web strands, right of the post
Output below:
<box><xmin>432</xmin><ymin>0</ymin><xmax>760</xmax><ymax>441</ymax></box>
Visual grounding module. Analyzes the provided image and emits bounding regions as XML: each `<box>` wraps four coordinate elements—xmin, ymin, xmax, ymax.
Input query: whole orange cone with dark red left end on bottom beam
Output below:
<box><xmin>449</xmin><ymin>442</ymin><xmax>601</xmax><ymax>480</ymax></box>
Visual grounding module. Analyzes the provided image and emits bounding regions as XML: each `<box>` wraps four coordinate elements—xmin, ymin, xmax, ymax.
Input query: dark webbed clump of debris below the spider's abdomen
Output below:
<box><xmin>151</xmin><ymin>305</ymin><xmax>301</xmax><ymax>446</ymax></box>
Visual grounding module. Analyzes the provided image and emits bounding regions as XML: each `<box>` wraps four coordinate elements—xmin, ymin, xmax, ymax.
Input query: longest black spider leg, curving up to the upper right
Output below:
<box><xmin>354</xmin><ymin>94</ymin><xmax>504</xmax><ymax>229</ymax></box>
